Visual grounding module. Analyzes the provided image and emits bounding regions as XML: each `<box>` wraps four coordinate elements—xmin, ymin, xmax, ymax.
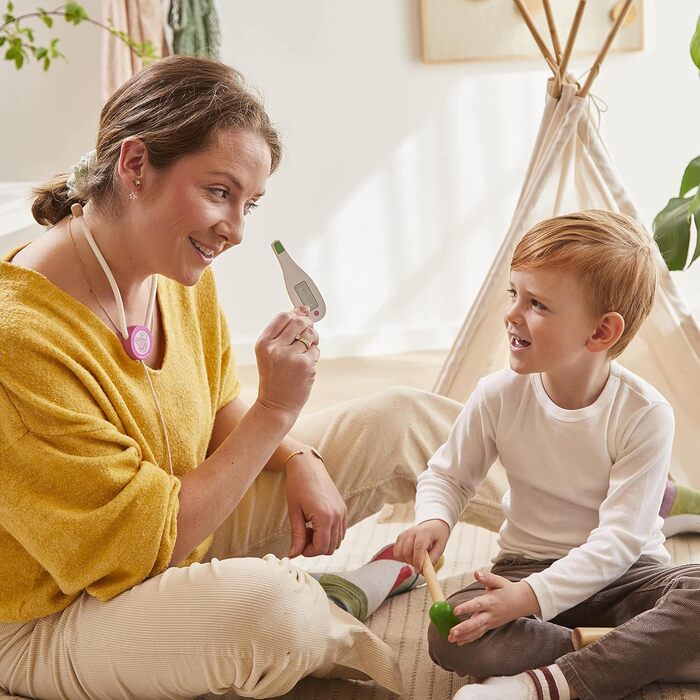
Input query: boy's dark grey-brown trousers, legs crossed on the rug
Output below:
<box><xmin>428</xmin><ymin>556</ymin><xmax>700</xmax><ymax>700</ymax></box>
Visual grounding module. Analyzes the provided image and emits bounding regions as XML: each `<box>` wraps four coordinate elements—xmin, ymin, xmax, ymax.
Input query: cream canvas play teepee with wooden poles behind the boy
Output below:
<box><xmin>434</xmin><ymin>0</ymin><xmax>700</xmax><ymax>488</ymax></box>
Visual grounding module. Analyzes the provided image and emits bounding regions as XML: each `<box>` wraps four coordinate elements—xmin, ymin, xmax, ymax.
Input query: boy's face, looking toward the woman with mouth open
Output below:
<box><xmin>505</xmin><ymin>270</ymin><xmax>598</xmax><ymax>374</ymax></box>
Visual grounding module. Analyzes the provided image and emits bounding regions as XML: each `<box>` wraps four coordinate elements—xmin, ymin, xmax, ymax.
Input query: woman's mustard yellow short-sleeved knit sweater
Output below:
<box><xmin>0</xmin><ymin>251</ymin><xmax>239</xmax><ymax>622</ymax></box>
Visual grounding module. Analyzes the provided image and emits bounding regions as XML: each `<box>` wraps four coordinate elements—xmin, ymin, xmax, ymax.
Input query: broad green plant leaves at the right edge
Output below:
<box><xmin>653</xmin><ymin>18</ymin><xmax>700</xmax><ymax>270</ymax></box>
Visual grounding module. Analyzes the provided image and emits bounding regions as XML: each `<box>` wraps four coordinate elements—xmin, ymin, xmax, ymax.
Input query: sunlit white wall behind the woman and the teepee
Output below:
<box><xmin>0</xmin><ymin>0</ymin><xmax>700</xmax><ymax>362</ymax></box>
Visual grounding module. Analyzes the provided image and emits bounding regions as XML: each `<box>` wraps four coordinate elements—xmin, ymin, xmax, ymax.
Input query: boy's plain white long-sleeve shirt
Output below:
<box><xmin>416</xmin><ymin>362</ymin><xmax>674</xmax><ymax>620</ymax></box>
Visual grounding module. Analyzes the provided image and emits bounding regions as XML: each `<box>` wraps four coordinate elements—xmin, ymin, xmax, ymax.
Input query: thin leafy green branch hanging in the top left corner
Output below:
<box><xmin>0</xmin><ymin>2</ymin><xmax>160</xmax><ymax>70</ymax></box>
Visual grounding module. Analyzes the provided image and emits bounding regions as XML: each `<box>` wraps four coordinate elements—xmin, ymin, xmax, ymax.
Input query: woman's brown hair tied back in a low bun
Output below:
<box><xmin>32</xmin><ymin>56</ymin><xmax>282</xmax><ymax>226</ymax></box>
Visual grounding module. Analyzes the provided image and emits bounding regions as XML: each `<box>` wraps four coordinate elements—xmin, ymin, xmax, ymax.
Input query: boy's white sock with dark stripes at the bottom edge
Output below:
<box><xmin>453</xmin><ymin>664</ymin><xmax>571</xmax><ymax>700</ymax></box>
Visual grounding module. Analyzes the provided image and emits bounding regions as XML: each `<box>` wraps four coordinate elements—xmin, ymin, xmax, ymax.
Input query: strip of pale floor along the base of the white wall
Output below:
<box><xmin>238</xmin><ymin>350</ymin><xmax>447</xmax><ymax>412</ymax></box>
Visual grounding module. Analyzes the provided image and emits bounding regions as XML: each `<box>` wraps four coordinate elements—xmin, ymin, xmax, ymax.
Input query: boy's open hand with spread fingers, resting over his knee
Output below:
<box><xmin>447</xmin><ymin>571</ymin><xmax>540</xmax><ymax>646</ymax></box>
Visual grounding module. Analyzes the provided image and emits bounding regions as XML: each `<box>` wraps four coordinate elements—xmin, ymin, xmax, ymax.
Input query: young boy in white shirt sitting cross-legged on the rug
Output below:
<box><xmin>394</xmin><ymin>211</ymin><xmax>700</xmax><ymax>700</ymax></box>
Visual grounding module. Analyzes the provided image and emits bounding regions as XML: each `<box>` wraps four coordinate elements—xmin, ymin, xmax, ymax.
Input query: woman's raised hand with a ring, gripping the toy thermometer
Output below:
<box><xmin>255</xmin><ymin>307</ymin><xmax>320</xmax><ymax>422</ymax></box>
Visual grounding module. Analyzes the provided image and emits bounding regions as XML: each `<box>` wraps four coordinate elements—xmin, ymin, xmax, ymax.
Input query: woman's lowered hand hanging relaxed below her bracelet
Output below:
<box><xmin>286</xmin><ymin>451</ymin><xmax>348</xmax><ymax>557</ymax></box>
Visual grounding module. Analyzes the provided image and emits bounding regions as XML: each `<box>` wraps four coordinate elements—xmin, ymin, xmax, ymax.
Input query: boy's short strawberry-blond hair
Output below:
<box><xmin>511</xmin><ymin>209</ymin><xmax>657</xmax><ymax>358</ymax></box>
